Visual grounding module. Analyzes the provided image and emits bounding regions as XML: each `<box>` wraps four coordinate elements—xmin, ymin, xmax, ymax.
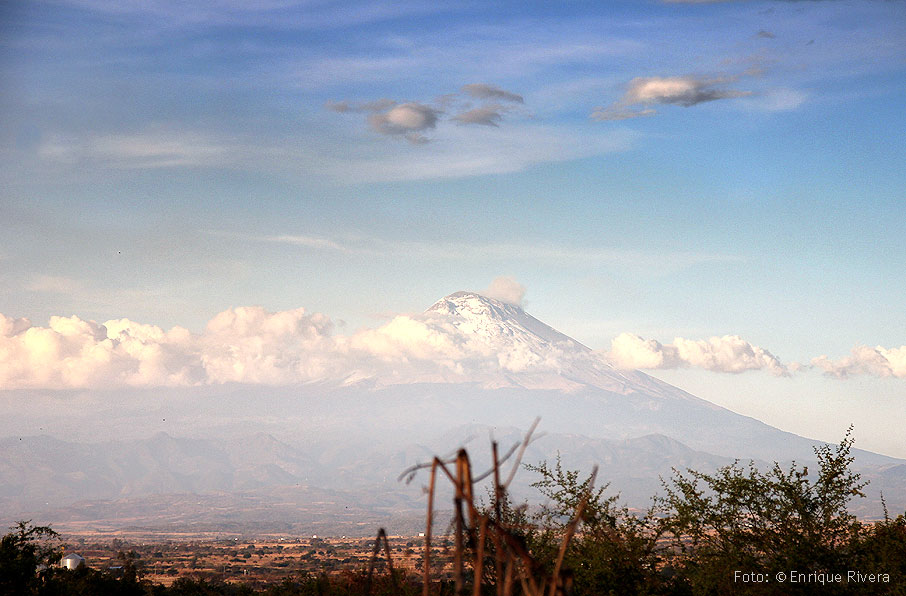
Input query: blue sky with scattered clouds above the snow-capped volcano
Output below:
<box><xmin>0</xmin><ymin>0</ymin><xmax>906</xmax><ymax>457</ymax></box>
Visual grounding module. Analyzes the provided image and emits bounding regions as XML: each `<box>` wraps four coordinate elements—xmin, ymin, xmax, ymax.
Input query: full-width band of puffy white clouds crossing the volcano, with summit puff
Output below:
<box><xmin>0</xmin><ymin>308</ymin><xmax>906</xmax><ymax>390</ymax></box>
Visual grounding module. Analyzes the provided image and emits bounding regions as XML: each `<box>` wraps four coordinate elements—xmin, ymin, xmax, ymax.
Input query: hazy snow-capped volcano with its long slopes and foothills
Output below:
<box><xmin>0</xmin><ymin>292</ymin><xmax>906</xmax><ymax>534</ymax></box>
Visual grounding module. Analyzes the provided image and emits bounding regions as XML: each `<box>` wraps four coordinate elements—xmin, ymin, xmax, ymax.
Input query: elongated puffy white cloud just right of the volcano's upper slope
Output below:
<box><xmin>607</xmin><ymin>333</ymin><xmax>790</xmax><ymax>376</ymax></box>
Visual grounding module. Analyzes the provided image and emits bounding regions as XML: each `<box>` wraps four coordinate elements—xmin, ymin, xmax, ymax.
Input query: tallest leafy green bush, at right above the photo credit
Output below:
<box><xmin>662</xmin><ymin>432</ymin><xmax>866</xmax><ymax>594</ymax></box>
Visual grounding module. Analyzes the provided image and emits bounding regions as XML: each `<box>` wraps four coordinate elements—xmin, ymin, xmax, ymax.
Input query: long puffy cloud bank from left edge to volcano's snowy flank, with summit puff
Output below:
<box><xmin>0</xmin><ymin>302</ymin><xmax>561</xmax><ymax>390</ymax></box>
